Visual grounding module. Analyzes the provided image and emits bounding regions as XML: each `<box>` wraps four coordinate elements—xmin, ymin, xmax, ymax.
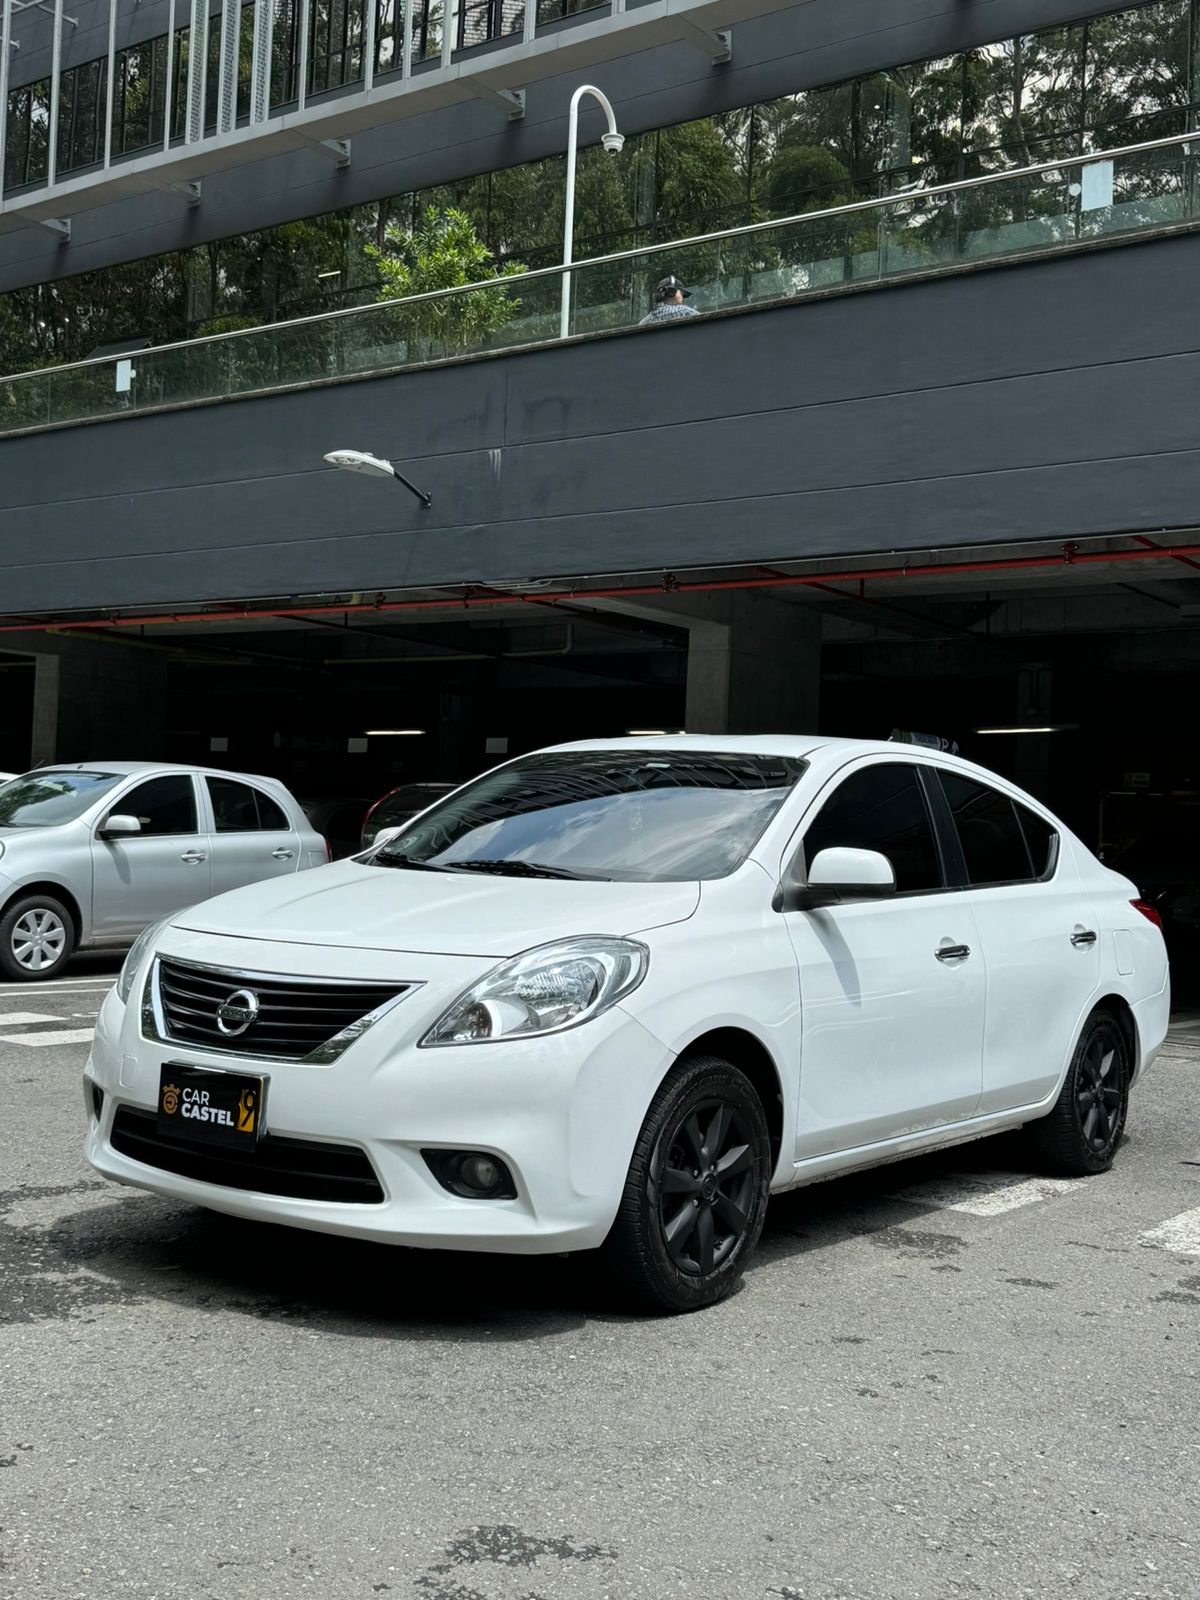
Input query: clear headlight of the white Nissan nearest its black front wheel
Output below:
<box><xmin>421</xmin><ymin>938</ymin><xmax>650</xmax><ymax>1046</ymax></box>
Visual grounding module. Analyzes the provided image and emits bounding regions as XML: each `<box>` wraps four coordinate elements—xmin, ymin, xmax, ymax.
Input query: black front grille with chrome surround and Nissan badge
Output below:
<box><xmin>142</xmin><ymin>957</ymin><xmax>416</xmax><ymax>1064</ymax></box>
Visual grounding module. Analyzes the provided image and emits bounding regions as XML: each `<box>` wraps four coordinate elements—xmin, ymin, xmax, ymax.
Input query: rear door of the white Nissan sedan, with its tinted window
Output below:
<box><xmin>938</xmin><ymin>768</ymin><xmax>1101</xmax><ymax>1115</ymax></box>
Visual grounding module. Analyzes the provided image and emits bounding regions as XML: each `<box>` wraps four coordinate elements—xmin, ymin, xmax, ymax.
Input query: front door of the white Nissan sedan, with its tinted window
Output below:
<box><xmin>787</xmin><ymin>762</ymin><xmax>986</xmax><ymax>1162</ymax></box>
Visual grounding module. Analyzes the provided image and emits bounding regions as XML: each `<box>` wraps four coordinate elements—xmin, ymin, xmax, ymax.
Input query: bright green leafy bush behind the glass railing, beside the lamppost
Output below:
<box><xmin>365</xmin><ymin>206</ymin><xmax>525</xmax><ymax>360</ymax></box>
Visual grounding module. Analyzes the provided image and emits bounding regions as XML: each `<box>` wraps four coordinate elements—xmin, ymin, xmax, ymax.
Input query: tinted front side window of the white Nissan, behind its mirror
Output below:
<box><xmin>805</xmin><ymin>762</ymin><xmax>947</xmax><ymax>893</ymax></box>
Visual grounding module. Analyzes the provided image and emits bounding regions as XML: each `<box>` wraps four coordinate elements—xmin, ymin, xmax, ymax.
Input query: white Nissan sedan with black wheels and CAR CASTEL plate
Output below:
<box><xmin>85</xmin><ymin>736</ymin><xmax>1168</xmax><ymax>1310</ymax></box>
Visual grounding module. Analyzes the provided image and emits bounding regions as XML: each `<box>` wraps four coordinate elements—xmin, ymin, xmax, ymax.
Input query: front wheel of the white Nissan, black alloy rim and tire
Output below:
<box><xmin>603</xmin><ymin>1054</ymin><xmax>771</xmax><ymax>1312</ymax></box>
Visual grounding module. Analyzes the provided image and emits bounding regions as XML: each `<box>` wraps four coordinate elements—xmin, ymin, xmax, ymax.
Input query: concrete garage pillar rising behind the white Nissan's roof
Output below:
<box><xmin>592</xmin><ymin>590</ymin><xmax>821</xmax><ymax>733</ymax></box>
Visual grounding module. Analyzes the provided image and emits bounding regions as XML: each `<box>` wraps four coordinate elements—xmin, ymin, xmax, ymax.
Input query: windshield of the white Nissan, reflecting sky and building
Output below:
<box><xmin>370</xmin><ymin>750</ymin><xmax>805</xmax><ymax>883</ymax></box>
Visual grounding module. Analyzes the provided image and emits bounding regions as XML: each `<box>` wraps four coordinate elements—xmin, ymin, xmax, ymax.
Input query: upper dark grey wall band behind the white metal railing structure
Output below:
<box><xmin>0</xmin><ymin>0</ymin><xmax>1145</xmax><ymax>293</ymax></box>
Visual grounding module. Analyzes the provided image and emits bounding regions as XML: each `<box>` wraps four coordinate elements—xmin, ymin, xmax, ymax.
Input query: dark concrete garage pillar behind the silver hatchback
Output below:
<box><xmin>24</xmin><ymin>635</ymin><xmax>166</xmax><ymax>766</ymax></box>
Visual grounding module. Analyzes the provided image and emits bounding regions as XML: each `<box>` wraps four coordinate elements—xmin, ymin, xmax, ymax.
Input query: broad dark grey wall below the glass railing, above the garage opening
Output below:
<box><xmin>0</xmin><ymin>235</ymin><xmax>1200</xmax><ymax>613</ymax></box>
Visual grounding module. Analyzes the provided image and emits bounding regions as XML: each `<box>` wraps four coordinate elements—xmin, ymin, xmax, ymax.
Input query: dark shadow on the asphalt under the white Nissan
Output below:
<box><xmin>42</xmin><ymin>1138</ymin><xmax>1081</xmax><ymax>1342</ymax></box>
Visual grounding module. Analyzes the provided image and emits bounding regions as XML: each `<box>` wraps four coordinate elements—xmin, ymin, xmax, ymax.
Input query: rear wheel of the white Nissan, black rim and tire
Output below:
<box><xmin>1026</xmin><ymin>1011</ymin><xmax>1130</xmax><ymax>1178</ymax></box>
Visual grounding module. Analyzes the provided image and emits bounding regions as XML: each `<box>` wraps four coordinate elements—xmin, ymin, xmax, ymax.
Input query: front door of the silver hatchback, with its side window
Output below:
<box><xmin>91</xmin><ymin>773</ymin><xmax>211</xmax><ymax>939</ymax></box>
